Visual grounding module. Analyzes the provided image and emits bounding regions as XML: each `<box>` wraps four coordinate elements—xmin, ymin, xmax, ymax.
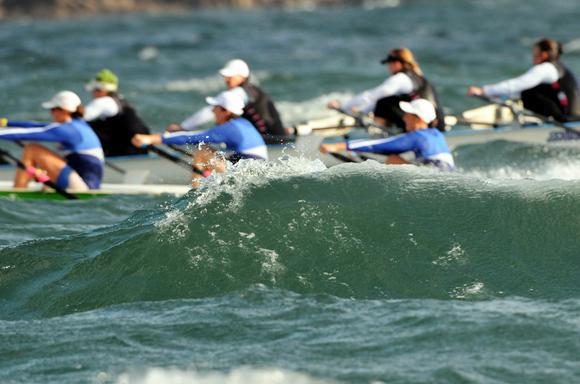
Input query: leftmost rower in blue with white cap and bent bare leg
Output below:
<box><xmin>0</xmin><ymin>91</ymin><xmax>104</xmax><ymax>190</ymax></box>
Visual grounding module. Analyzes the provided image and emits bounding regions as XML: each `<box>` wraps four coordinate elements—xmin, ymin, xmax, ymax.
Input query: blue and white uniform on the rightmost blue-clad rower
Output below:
<box><xmin>346</xmin><ymin>128</ymin><xmax>455</xmax><ymax>171</ymax></box>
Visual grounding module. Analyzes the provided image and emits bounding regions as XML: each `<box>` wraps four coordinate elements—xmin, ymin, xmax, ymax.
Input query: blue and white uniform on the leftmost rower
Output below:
<box><xmin>0</xmin><ymin>119</ymin><xmax>105</xmax><ymax>189</ymax></box>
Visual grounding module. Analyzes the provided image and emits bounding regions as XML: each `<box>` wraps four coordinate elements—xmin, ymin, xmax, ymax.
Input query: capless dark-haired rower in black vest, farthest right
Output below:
<box><xmin>467</xmin><ymin>39</ymin><xmax>580</xmax><ymax>122</ymax></box>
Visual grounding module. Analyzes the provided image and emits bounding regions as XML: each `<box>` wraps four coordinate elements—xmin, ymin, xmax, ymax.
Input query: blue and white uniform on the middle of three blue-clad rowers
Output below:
<box><xmin>162</xmin><ymin>117</ymin><xmax>268</xmax><ymax>160</ymax></box>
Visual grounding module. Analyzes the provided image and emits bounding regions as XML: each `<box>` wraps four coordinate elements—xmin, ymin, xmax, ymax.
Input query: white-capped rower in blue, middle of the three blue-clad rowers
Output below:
<box><xmin>132</xmin><ymin>90</ymin><xmax>268</xmax><ymax>187</ymax></box>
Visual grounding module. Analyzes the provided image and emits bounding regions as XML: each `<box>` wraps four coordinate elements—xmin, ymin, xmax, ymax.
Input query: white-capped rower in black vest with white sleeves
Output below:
<box><xmin>167</xmin><ymin>59</ymin><xmax>295</xmax><ymax>144</ymax></box>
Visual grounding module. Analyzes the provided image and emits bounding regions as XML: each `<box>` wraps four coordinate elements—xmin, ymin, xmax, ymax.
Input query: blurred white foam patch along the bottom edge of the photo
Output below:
<box><xmin>116</xmin><ymin>367</ymin><xmax>334</xmax><ymax>384</ymax></box>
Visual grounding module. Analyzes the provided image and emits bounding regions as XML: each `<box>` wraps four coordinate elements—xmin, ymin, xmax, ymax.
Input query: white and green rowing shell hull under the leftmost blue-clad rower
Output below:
<box><xmin>0</xmin><ymin>181</ymin><xmax>191</xmax><ymax>200</ymax></box>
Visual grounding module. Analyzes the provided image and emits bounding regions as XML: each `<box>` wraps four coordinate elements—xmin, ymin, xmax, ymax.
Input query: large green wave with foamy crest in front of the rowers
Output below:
<box><xmin>0</xmin><ymin>159</ymin><xmax>580</xmax><ymax>316</ymax></box>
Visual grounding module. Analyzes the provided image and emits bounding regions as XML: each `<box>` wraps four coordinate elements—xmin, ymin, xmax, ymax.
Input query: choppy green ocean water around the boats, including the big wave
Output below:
<box><xmin>0</xmin><ymin>0</ymin><xmax>580</xmax><ymax>383</ymax></box>
